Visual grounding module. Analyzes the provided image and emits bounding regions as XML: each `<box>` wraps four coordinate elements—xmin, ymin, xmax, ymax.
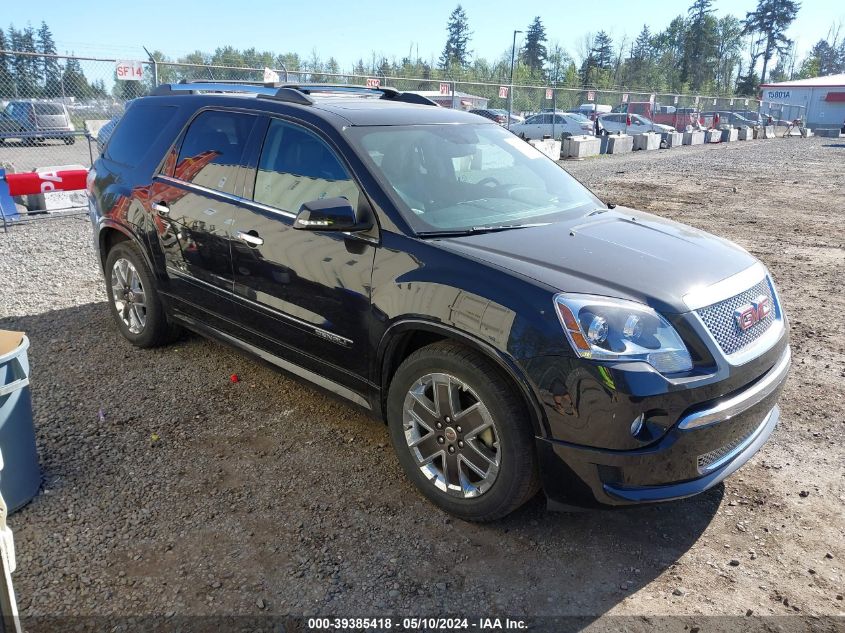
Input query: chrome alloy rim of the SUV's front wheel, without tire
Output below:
<box><xmin>403</xmin><ymin>373</ymin><xmax>501</xmax><ymax>498</ymax></box>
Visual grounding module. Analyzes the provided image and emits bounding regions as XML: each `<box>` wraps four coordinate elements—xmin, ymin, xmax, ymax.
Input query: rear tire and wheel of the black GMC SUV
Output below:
<box><xmin>105</xmin><ymin>241</ymin><xmax>179</xmax><ymax>347</ymax></box>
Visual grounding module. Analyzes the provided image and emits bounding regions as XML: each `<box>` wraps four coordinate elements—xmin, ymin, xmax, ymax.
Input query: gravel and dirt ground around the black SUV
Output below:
<box><xmin>0</xmin><ymin>133</ymin><xmax>845</xmax><ymax>630</ymax></box>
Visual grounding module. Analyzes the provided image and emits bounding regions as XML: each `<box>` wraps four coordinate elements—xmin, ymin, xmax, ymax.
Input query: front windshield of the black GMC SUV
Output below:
<box><xmin>348</xmin><ymin>125</ymin><xmax>602</xmax><ymax>233</ymax></box>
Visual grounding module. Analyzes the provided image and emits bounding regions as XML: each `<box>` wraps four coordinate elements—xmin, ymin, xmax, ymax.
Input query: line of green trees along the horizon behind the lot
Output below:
<box><xmin>0</xmin><ymin>0</ymin><xmax>845</xmax><ymax>100</ymax></box>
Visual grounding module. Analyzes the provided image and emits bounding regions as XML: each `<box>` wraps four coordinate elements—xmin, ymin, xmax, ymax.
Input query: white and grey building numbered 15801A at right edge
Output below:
<box><xmin>760</xmin><ymin>73</ymin><xmax>845</xmax><ymax>128</ymax></box>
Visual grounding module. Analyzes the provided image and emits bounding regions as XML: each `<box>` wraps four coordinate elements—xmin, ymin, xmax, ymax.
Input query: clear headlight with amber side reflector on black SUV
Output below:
<box><xmin>555</xmin><ymin>293</ymin><xmax>692</xmax><ymax>374</ymax></box>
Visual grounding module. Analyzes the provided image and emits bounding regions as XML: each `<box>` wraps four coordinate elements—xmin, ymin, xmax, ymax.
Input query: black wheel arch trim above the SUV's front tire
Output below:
<box><xmin>373</xmin><ymin>318</ymin><xmax>549</xmax><ymax>437</ymax></box>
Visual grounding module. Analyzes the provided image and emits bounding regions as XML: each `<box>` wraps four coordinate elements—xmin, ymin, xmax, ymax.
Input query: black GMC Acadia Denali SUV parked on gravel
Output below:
<box><xmin>89</xmin><ymin>84</ymin><xmax>790</xmax><ymax>521</ymax></box>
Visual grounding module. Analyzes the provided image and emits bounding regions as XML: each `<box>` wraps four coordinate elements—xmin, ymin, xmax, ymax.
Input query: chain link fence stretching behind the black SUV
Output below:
<box><xmin>0</xmin><ymin>50</ymin><xmax>803</xmax><ymax>179</ymax></box>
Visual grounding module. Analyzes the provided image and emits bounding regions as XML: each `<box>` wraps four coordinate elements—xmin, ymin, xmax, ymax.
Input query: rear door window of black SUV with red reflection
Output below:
<box><xmin>174</xmin><ymin>110</ymin><xmax>257</xmax><ymax>193</ymax></box>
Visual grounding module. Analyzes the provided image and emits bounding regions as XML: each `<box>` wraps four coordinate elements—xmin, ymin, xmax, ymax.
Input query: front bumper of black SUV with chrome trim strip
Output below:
<box><xmin>537</xmin><ymin>346</ymin><xmax>791</xmax><ymax>505</ymax></box>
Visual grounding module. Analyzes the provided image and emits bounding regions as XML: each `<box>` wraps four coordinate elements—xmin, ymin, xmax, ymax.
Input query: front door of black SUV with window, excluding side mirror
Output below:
<box><xmin>232</xmin><ymin>119</ymin><xmax>378</xmax><ymax>389</ymax></box>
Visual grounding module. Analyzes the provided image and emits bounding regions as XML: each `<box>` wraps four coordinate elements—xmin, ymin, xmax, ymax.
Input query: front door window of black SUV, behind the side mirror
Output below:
<box><xmin>253</xmin><ymin>119</ymin><xmax>358</xmax><ymax>213</ymax></box>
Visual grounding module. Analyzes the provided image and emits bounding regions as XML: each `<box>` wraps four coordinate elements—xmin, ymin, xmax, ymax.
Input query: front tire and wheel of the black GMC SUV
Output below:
<box><xmin>387</xmin><ymin>342</ymin><xmax>540</xmax><ymax>522</ymax></box>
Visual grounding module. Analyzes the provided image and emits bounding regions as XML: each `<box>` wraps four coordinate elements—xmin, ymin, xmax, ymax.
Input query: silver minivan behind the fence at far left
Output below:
<box><xmin>0</xmin><ymin>100</ymin><xmax>76</xmax><ymax>145</ymax></box>
